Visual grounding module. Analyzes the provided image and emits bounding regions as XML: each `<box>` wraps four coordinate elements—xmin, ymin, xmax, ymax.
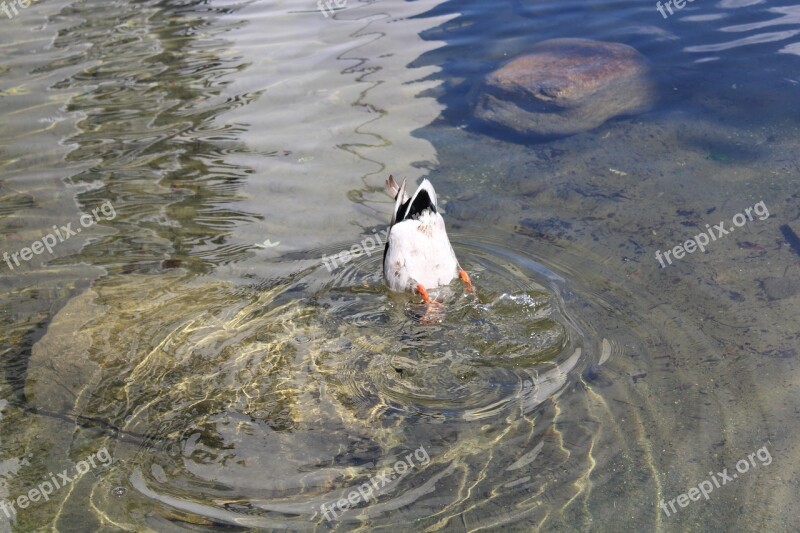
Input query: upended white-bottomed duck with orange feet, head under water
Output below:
<box><xmin>383</xmin><ymin>176</ymin><xmax>473</xmax><ymax>304</ymax></box>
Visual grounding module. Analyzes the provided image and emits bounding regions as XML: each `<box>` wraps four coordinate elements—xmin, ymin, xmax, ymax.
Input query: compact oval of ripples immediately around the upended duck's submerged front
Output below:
<box><xmin>317</xmin><ymin>237</ymin><xmax>585</xmax><ymax>420</ymax></box>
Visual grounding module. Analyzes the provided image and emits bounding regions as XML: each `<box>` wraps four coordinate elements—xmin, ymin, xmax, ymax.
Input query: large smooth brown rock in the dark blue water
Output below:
<box><xmin>473</xmin><ymin>39</ymin><xmax>656</xmax><ymax>136</ymax></box>
